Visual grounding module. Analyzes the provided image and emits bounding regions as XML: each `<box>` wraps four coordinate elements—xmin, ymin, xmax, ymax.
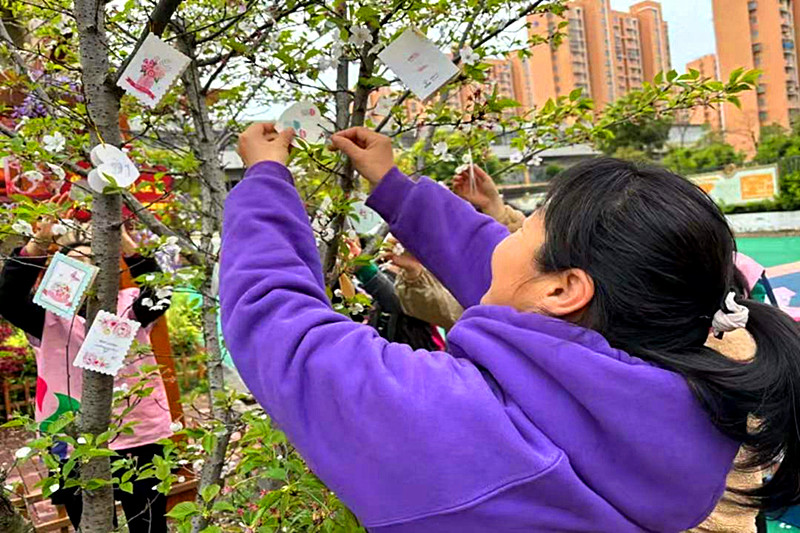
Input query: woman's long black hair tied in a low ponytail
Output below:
<box><xmin>537</xmin><ymin>159</ymin><xmax>800</xmax><ymax>510</ymax></box>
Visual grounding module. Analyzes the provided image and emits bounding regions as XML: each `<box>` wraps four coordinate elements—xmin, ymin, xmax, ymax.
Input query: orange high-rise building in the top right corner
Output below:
<box><xmin>713</xmin><ymin>0</ymin><xmax>800</xmax><ymax>153</ymax></box>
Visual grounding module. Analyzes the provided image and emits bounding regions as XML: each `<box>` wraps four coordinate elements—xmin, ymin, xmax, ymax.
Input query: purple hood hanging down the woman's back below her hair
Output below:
<box><xmin>448</xmin><ymin>306</ymin><xmax>739</xmax><ymax>531</ymax></box>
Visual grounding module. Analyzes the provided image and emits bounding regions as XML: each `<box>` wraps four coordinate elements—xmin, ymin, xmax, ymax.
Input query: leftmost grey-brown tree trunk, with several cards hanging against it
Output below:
<box><xmin>74</xmin><ymin>0</ymin><xmax>122</xmax><ymax>533</ymax></box>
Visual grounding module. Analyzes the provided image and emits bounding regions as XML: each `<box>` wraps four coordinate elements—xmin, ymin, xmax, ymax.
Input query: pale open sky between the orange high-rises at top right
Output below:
<box><xmin>611</xmin><ymin>0</ymin><xmax>716</xmax><ymax>71</ymax></box>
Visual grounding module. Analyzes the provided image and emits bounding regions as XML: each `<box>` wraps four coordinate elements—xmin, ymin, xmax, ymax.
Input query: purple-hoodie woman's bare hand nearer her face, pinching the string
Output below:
<box><xmin>331</xmin><ymin>127</ymin><xmax>394</xmax><ymax>185</ymax></box>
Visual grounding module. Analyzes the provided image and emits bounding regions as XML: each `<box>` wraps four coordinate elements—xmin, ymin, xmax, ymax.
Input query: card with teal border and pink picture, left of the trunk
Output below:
<box><xmin>33</xmin><ymin>253</ymin><xmax>98</xmax><ymax>318</ymax></box>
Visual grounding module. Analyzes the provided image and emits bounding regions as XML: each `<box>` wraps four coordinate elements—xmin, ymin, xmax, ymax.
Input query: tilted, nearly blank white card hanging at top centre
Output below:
<box><xmin>378</xmin><ymin>28</ymin><xmax>458</xmax><ymax>100</ymax></box>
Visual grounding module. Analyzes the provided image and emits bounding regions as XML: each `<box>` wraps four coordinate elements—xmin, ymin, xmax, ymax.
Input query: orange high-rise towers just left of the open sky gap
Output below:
<box><xmin>529</xmin><ymin>0</ymin><xmax>671</xmax><ymax>107</ymax></box>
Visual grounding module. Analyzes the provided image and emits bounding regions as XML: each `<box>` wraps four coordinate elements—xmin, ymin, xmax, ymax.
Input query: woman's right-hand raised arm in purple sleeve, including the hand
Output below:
<box><xmin>333</xmin><ymin>128</ymin><xmax>508</xmax><ymax>308</ymax></box>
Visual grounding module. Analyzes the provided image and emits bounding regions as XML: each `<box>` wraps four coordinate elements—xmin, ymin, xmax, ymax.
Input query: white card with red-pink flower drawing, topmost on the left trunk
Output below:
<box><xmin>117</xmin><ymin>33</ymin><xmax>189</xmax><ymax>108</ymax></box>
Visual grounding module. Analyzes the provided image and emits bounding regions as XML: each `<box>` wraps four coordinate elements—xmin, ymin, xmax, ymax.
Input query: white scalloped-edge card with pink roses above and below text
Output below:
<box><xmin>72</xmin><ymin>311</ymin><xmax>141</xmax><ymax>376</ymax></box>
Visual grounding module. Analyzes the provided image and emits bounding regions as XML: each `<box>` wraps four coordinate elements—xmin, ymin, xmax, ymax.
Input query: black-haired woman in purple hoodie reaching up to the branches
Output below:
<box><xmin>220</xmin><ymin>124</ymin><xmax>800</xmax><ymax>533</ymax></box>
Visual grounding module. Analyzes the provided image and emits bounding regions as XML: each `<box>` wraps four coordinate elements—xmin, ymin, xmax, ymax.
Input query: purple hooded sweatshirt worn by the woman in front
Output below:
<box><xmin>220</xmin><ymin>162</ymin><xmax>738</xmax><ymax>533</ymax></box>
